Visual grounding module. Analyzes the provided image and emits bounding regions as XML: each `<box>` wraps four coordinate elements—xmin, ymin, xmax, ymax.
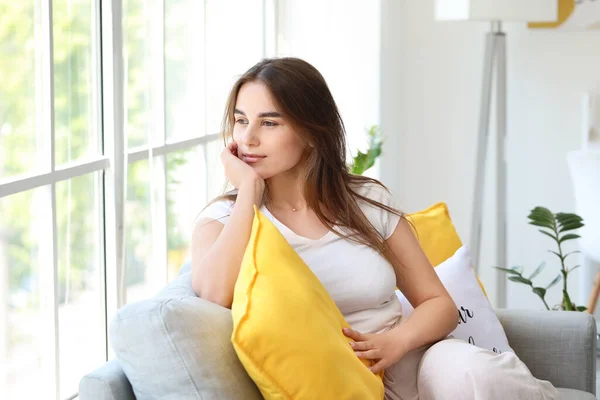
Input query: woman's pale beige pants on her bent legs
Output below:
<box><xmin>383</xmin><ymin>338</ymin><xmax>559</xmax><ymax>400</ymax></box>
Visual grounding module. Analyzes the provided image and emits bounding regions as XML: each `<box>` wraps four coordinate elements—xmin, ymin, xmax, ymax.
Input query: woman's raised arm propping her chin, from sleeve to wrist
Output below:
<box><xmin>192</xmin><ymin>179</ymin><xmax>265</xmax><ymax>308</ymax></box>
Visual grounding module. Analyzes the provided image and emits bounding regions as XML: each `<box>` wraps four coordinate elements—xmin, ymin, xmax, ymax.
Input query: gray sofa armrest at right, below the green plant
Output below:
<box><xmin>495</xmin><ymin>309</ymin><xmax>597</xmax><ymax>394</ymax></box>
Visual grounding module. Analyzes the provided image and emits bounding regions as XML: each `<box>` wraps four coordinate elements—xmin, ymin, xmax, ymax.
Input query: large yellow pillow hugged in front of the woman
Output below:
<box><xmin>231</xmin><ymin>207</ymin><xmax>384</xmax><ymax>400</ymax></box>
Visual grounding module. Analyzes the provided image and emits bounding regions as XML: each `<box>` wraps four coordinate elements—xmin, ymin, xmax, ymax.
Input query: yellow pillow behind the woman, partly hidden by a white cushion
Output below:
<box><xmin>407</xmin><ymin>202</ymin><xmax>487</xmax><ymax>296</ymax></box>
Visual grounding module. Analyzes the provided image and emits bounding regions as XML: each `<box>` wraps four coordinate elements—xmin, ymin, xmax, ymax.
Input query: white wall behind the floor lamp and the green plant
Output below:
<box><xmin>380</xmin><ymin>0</ymin><xmax>600</xmax><ymax>309</ymax></box>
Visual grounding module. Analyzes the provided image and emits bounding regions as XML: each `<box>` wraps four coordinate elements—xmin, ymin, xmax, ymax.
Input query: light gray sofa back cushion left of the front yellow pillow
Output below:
<box><xmin>109</xmin><ymin>273</ymin><xmax>262</xmax><ymax>400</ymax></box>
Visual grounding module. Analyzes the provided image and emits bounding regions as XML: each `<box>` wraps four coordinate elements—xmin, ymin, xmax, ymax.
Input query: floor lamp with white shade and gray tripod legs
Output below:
<box><xmin>435</xmin><ymin>0</ymin><xmax>558</xmax><ymax>307</ymax></box>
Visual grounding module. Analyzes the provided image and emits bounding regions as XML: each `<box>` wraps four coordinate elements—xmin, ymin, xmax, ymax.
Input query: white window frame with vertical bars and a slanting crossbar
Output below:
<box><xmin>0</xmin><ymin>0</ymin><xmax>278</xmax><ymax>399</ymax></box>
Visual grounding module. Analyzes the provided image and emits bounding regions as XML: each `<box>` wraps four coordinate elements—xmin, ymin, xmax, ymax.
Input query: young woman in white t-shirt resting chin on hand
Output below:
<box><xmin>192</xmin><ymin>58</ymin><xmax>558</xmax><ymax>400</ymax></box>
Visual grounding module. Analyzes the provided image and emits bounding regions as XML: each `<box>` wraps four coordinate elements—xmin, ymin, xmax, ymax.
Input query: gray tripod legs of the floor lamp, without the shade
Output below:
<box><xmin>470</xmin><ymin>21</ymin><xmax>508</xmax><ymax>308</ymax></box>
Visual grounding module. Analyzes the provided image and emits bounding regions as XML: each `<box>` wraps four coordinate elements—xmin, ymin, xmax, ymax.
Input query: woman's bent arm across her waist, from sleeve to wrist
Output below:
<box><xmin>386</xmin><ymin>218</ymin><xmax>458</xmax><ymax>353</ymax></box>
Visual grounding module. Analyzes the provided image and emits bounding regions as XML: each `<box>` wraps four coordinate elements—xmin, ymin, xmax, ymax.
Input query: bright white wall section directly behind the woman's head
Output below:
<box><xmin>277</xmin><ymin>0</ymin><xmax>381</xmax><ymax>161</ymax></box>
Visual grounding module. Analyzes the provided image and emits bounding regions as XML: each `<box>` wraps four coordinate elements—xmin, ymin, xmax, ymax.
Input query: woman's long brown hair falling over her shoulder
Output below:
<box><xmin>214</xmin><ymin>57</ymin><xmax>403</xmax><ymax>261</ymax></box>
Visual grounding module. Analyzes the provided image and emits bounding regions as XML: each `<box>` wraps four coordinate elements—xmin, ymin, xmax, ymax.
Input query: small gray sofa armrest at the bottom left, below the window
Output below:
<box><xmin>79</xmin><ymin>360</ymin><xmax>135</xmax><ymax>400</ymax></box>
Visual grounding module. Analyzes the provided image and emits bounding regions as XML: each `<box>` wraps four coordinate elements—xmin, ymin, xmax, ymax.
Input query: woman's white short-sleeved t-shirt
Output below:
<box><xmin>200</xmin><ymin>183</ymin><xmax>402</xmax><ymax>333</ymax></box>
